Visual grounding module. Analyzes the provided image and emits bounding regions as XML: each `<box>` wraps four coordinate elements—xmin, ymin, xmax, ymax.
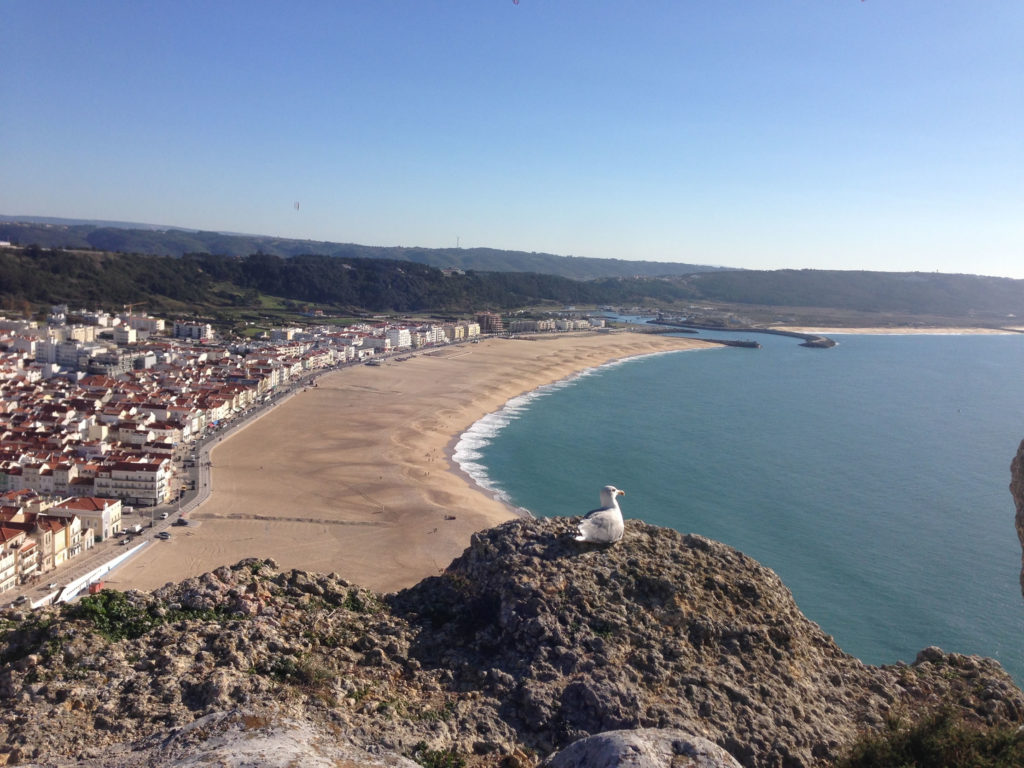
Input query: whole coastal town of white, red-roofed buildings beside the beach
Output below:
<box><xmin>0</xmin><ymin>305</ymin><xmax>603</xmax><ymax>604</ymax></box>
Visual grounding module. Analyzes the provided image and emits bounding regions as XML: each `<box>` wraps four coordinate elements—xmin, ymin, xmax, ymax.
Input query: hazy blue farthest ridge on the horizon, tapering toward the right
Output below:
<box><xmin>0</xmin><ymin>215</ymin><xmax>723</xmax><ymax>280</ymax></box>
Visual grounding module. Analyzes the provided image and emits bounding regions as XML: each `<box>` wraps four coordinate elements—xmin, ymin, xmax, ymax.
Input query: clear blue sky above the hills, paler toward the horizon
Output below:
<box><xmin>6</xmin><ymin>0</ymin><xmax>1024</xmax><ymax>278</ymax></box>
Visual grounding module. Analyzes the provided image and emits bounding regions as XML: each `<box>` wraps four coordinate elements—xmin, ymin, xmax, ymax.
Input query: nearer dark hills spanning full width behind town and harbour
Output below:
<box><xmin>0</xmin><ymin>246</ymin><xmax>1024</xmax><ymax>327</ymax></box>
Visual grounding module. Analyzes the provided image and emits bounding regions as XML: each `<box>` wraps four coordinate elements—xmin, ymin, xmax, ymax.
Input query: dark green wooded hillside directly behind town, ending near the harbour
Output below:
<box><xmin>0</xmin><ymin>247</ymin><xmax>655</xmax><ymax>311</ymax></box>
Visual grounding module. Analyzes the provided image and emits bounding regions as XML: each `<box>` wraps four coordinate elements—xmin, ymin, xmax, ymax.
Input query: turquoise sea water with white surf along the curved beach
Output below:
<box><xmin>457</xmin><ymin>334</ymin><xmax>1024</xmax><ymax>683</ymax></box>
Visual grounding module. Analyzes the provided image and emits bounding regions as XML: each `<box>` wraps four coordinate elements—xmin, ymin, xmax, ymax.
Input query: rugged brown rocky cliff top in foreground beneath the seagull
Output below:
<box><xmin>0</xmin><ymin>519</ymin><xmax>1024</xmax><ymax>768</ymax></box>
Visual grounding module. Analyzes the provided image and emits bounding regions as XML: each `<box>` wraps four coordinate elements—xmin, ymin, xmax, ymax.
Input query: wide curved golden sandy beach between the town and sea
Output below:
<box><xmin>106</xmin><ymin>333</ymin><xmax>706</xmax><ymax>592</ymax></box>
